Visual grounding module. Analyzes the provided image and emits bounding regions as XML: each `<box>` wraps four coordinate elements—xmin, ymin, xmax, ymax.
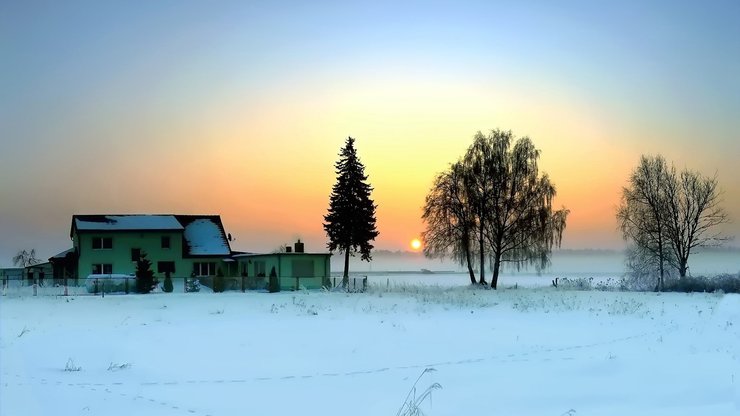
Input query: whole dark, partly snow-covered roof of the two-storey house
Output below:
<box><xmin>70</xmin><ymin>214</ymin><xmax>231</xmax><ymax>257</ymax></box>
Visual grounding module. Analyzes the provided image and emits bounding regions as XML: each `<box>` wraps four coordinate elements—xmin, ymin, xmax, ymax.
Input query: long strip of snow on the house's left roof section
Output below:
<box><xmin>75</xmin><ymin>215</ymin><xmax>183</xmax><ymax>231</ymax></box>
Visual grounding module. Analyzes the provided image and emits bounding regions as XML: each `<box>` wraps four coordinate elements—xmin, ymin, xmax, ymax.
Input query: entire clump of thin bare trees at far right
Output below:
<box><xmin>617</xmin><ymin>155</ymin><xmax>728</xmax><ymax>290</ymax></box>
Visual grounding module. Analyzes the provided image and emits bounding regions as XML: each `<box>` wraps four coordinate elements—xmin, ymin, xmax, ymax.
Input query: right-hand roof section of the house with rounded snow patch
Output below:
<box><xmin>175</xmin><ymin>215</ymin><xmax>231</xmax><ymax>257</ymax></box>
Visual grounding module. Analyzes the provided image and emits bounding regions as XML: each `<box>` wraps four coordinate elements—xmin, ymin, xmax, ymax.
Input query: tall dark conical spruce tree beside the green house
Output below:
<box><xmin>324</xmin><ymin>137</ymin><xmax>379</xmax><ymax>286</ymax></box>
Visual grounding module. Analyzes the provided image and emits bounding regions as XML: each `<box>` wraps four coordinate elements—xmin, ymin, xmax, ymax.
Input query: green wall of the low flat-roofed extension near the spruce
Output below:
<box><xmin>239</xmin><ymin>253</ymin><xmax>331</xmax><ymax>290</ymax></box>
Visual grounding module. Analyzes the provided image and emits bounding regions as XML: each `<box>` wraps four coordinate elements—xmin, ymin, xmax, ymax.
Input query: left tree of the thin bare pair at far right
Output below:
<box><xmin>617</xmin><ymin>156</ymin><xmax>675</xmax><ymax>290</ymax></box>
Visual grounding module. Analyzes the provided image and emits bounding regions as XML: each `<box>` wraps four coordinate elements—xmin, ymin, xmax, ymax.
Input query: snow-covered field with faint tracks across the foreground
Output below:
<box><xmin>0</xmin><ymin>284</ymin><xmax>740</xmax><ymax>416</ymax></box>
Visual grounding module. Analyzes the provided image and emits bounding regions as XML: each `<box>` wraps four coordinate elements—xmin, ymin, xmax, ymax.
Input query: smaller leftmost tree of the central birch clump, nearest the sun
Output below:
<box><xmin>421</xmin><ymin>162</ymin><xmax>476</xmax><ymax>284</ymax></box>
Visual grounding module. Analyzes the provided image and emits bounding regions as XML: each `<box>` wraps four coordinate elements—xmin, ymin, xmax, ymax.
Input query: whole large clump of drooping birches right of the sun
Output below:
<box><xmin>423</xmin><ymin>130</ymin><xmax>569</xmax><ymax>289</ymax></box>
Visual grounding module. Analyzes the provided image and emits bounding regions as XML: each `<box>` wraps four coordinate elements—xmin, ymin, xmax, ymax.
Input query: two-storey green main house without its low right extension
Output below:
<box><xmin>57</xmin><ymin>215</ymin><xmax>232</xmax><ymax>286</ymax></box>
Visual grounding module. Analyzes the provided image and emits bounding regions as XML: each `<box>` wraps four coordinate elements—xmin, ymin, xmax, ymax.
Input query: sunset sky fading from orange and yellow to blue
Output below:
<box><xmin>0</xmin><ymin>0</ymin><xmax>740</xmax><ymax>265</ymax></box>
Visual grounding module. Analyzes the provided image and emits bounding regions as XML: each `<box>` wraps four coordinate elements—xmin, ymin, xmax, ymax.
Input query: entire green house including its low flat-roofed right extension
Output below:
<box><xmin>47</xmin><ymin>214</ymin><xmax>331</xmax><ymax>290</ymax></box>
